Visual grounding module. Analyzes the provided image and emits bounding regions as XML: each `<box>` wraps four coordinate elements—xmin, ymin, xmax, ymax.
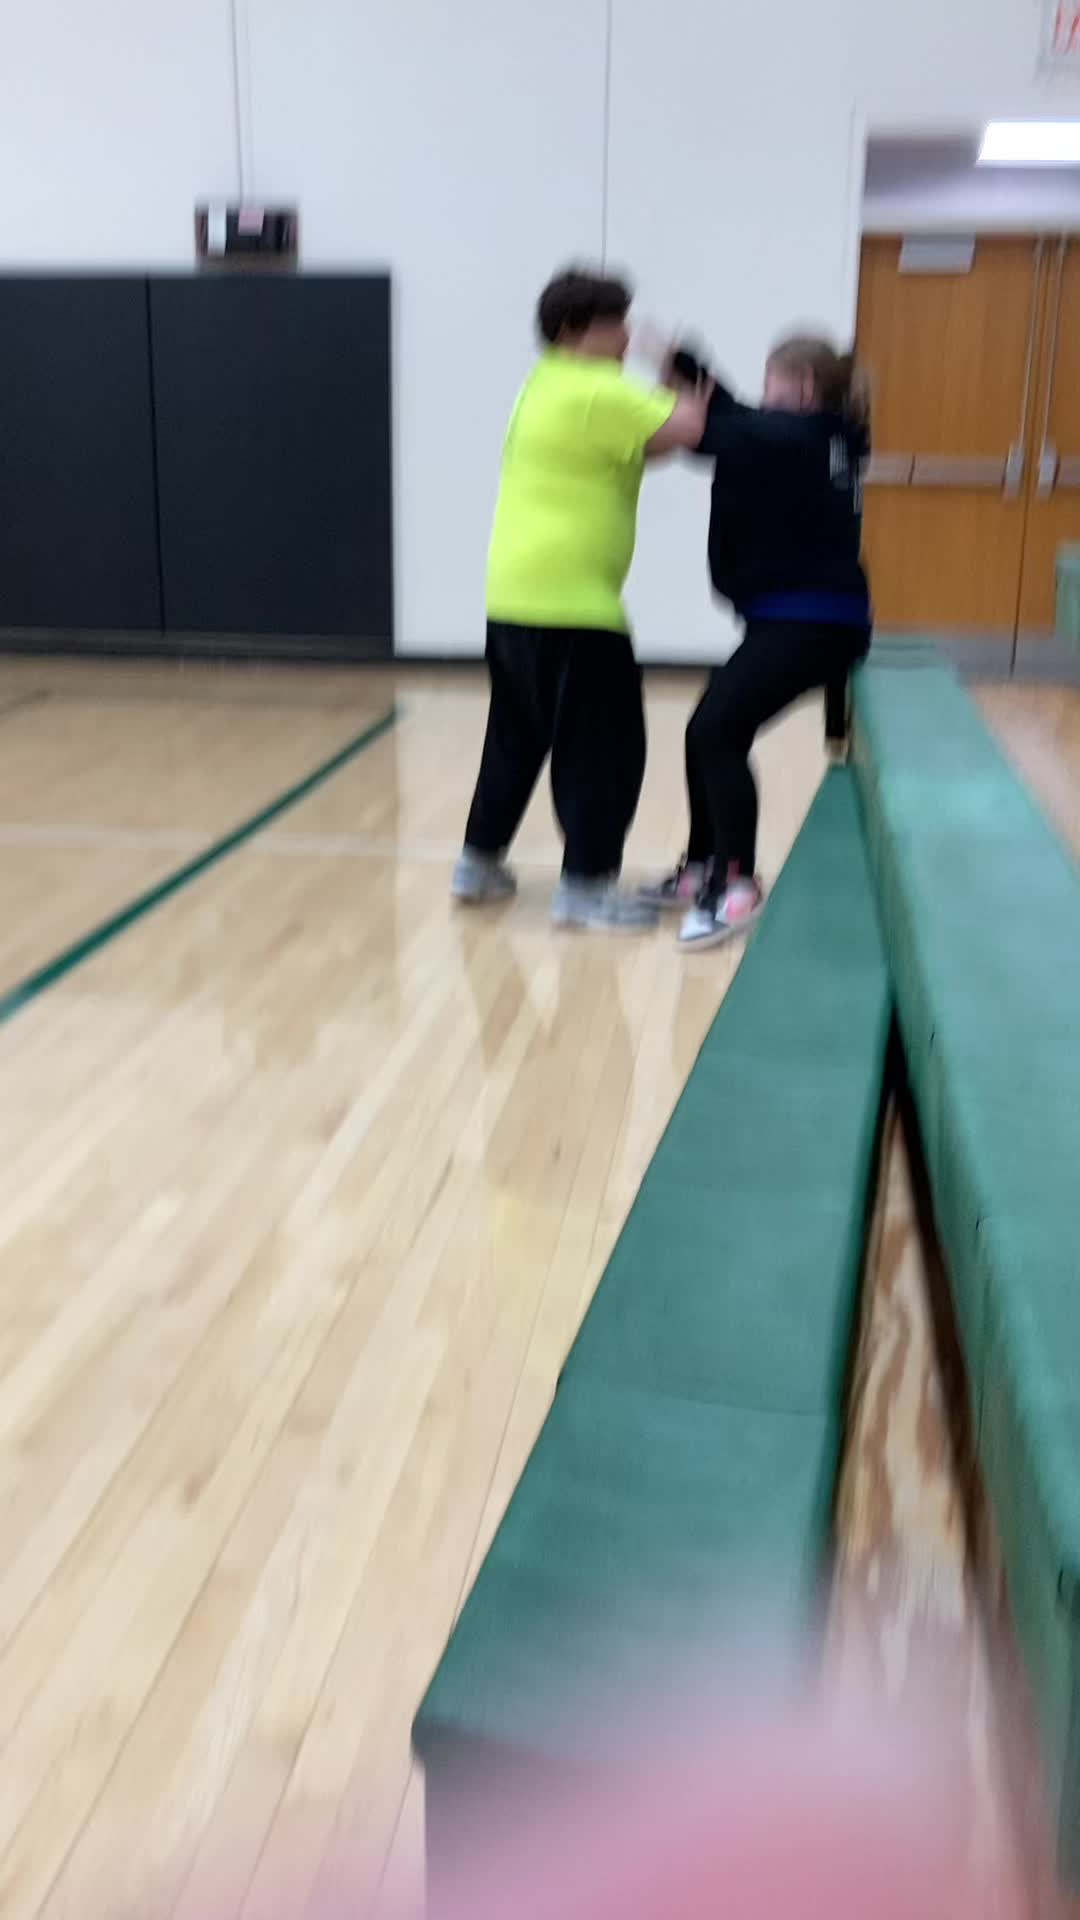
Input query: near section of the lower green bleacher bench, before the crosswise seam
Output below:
<box><xmin>417</xmin><ymin>1382</ymin><xmax>838</xmax><ymax>1763</ymax></box>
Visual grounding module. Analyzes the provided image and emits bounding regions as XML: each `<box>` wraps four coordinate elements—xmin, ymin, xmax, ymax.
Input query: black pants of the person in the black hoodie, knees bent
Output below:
<box><xmin>686</xmin><ymin>620</ymin><xmax>871</xmax><ymax>881</ymax></box>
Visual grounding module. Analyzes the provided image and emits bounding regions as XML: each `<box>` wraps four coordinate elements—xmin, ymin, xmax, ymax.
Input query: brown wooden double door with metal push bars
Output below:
<box><xmin>857</xmin><ymin>236</ymin><xmax>1080</xmax><ymax>651</ymax></box>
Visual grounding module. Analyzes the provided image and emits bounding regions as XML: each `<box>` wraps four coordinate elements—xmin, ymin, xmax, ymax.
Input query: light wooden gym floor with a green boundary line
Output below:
<box><xmin>0</xmin><ymin>660</ymin><xmax>1080</xmax><ymax>1920</ymax></box>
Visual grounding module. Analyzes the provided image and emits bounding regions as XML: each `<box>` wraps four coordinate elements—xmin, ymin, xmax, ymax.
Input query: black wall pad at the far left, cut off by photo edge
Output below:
<box><xmin>0</xmin><ymin>275</ymin><xmax>161</xmax><ymax>630</ymax></box>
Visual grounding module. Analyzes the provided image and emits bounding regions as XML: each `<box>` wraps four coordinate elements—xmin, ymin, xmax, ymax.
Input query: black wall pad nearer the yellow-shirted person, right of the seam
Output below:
<box><xmin>150</xmin><ymin>273</ymin><xmax>392</xmax><ymax>659</ymax></box>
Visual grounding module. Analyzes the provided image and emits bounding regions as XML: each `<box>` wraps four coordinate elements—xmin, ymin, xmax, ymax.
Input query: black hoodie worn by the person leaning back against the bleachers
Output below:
<box><xmin>698</xmin><ymin>386</ymin><xmax>871</xmax><ymax>628</ymax></box>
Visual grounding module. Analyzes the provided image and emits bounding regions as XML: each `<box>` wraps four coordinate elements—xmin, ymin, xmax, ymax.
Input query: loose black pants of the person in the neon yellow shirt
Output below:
<box><xmin>465</xmin><ymin>620</ymin><xmax>646</xmax><ymax>879</ymax></box>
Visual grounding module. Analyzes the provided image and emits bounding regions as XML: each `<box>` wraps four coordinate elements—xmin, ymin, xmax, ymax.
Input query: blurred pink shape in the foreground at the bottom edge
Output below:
<box><xmin>418</xmin><ymin>1711</ymin><xmax>1001</xmax><ymax>1920</ymax></box>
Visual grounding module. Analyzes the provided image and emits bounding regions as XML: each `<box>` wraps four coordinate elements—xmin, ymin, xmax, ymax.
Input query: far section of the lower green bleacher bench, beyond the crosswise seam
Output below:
<box><xmin>567</xmin><ymin>772</ymin><xmax>890</xmax><ymax>1413</ymax></box>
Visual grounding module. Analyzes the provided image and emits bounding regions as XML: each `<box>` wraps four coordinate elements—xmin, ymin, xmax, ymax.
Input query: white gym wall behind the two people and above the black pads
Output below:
<box><xmin>0</xmin><ymin>0</ymin><xmax>1080</xmax><ymax>659</ymax></box>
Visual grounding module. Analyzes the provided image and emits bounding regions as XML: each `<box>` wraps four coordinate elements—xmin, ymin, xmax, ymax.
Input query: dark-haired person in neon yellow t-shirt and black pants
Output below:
<box><xmin>454</xmin><ymin>273</ymin><xmax>707</xmax><ymax>929</ymax></box>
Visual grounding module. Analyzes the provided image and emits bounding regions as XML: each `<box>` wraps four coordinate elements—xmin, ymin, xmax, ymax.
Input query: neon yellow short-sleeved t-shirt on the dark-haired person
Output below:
<box><xmin>488</xmin><ymin>348</ymin><xmax>675</xmax><ymax>634</ymax></box>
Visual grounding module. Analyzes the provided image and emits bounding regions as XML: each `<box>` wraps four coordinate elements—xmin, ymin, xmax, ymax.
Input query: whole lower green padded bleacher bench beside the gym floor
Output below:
<box><xmin>413</xmin><ymin>770</ymin><xmax>892</xmax><ymax>1884</ymax></box>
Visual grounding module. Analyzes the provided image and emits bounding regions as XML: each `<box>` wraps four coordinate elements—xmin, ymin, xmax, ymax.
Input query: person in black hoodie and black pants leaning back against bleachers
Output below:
<box><xmin>646</xmin><ymin>336</ymin><xmax>872</xmax><ymax>948</ymax></box>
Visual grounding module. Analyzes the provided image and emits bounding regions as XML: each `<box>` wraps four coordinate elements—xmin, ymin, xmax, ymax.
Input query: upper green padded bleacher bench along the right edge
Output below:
<box><xmin>853</xmin><ymin>660</ymin><xmax>1080</xmax><ymax>1882</ymax></box>
